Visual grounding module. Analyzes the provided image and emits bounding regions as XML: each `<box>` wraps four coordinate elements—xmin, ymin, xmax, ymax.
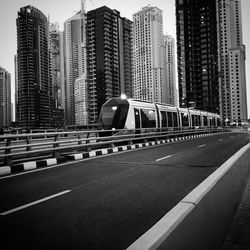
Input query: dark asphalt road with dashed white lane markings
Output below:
<box><xmin>0</xmin><ymin>133</ymin><xmax>249</xmax><ymax>249</ymax></box>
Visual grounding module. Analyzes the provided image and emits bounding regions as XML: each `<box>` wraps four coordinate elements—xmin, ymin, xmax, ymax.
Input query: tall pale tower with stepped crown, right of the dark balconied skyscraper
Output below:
<box><xmin>133</xmin><ymin>6</ymin><xmax>167</xmax><ymax>103</ymax></box>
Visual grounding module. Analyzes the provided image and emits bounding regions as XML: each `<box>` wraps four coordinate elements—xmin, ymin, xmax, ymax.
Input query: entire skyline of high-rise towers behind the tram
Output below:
<box><xmin>0</xmin><ymin>0</ymin><xmax>247</xmax><ymax>129</ymax></box>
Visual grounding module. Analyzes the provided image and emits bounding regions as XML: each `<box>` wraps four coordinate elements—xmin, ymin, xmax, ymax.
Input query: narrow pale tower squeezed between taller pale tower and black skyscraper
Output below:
<box><xmin>164</xmin><ymin>35</ymin><xmax>178</xmax><ymax>106</ymax></box>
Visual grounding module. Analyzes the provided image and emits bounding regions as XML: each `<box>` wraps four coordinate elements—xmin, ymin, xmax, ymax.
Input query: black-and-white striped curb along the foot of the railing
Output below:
<box><xmin>0</xmin><ymin>133</ymin><xmax>214</xmax><ymax>176</ymax></box>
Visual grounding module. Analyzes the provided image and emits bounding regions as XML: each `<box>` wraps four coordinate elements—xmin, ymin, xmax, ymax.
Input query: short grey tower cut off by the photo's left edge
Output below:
<box><xmin>0</xmin><ymin>66</ymin><xmax>11</xmax><ymax>128</ymax></box>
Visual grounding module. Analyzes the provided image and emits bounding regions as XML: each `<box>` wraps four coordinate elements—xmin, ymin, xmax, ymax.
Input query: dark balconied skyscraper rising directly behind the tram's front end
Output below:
<box><xmin>87</xmin><ymin>6</ymin><xmax>132</xmax><ymax>123</ymax></box>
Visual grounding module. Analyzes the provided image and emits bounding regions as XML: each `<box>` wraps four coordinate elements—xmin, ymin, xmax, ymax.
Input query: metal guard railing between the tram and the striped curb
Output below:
<box><xmin>0</xmin><ymin>127</ymin><xmax>227</xmax><ymax>166</ymax></box>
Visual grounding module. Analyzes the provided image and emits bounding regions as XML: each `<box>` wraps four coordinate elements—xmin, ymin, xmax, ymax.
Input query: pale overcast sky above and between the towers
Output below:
<box><xmin>0</xmin><ymin>0</ymin><xmax>250</xmax><ymax>117</ymax></box>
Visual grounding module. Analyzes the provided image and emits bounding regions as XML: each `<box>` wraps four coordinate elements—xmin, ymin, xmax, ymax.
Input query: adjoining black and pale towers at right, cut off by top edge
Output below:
<box><xmin>176</xmin><ymin>0</ymin><xmax>247</xmax><ymax>124</ymax></box>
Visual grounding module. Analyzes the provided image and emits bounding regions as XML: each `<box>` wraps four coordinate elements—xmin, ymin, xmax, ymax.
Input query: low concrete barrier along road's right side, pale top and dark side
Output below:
<box><xmin>128</xmin><ymin>143</ymin><xmax>250</xmax><ymax>250</ymax></box>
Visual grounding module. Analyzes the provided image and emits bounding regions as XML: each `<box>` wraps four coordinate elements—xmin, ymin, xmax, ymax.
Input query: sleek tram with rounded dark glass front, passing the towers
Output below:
<box><xmin>98</xmin><ymin>97</ymin><xmax>221</xmax><ymax>133</ymax></box>
